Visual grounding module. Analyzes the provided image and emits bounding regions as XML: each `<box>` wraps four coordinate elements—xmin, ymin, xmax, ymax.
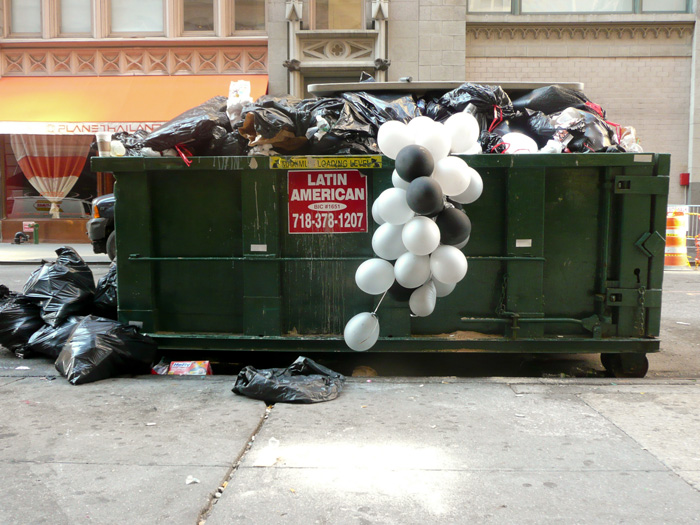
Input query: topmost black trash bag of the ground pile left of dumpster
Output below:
<box><xmin>22</xmin><ymin>246</ymin><xmax>95</xmax><ymax>327</ymax></box>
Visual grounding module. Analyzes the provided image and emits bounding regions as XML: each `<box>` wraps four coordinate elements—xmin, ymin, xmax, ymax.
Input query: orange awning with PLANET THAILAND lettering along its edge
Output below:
<box><xmin>0</xmin><ymin>75</ymin><xmax>267</xmax><ymax>135</ymax></box>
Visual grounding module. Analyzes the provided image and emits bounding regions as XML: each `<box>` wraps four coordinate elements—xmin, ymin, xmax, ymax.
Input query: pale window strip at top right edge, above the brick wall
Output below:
<box><xmin>467</xmin><ymin>0</ymin><xmax>690</xmax><ymax>14</ymax></box>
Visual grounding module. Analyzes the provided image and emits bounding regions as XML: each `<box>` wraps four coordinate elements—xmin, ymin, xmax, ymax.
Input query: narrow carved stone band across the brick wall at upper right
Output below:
<box><xmin>467</xmin><ymin>24</ymin><xmax>693</xmax><ymax>40</ymax></box>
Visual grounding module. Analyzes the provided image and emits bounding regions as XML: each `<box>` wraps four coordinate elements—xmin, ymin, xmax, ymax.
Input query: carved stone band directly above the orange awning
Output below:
<box><xmin>0</xmin><ymin>46</ymin><xmax>267</xmax><ymax>76</ymax></box>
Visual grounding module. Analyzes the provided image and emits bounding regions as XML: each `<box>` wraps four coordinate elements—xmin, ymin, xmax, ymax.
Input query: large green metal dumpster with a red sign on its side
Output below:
<box><xmin>92</xmin><ymin>153</ymin><xmax>670</xmax><ymax>376</ymax></box>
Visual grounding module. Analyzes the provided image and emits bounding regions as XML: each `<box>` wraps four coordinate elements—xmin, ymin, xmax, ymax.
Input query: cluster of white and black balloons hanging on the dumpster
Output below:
<box><xmin>343</xmin><ymin>113</ymin><xmax>483</xmax><ymax>351</ymax></box>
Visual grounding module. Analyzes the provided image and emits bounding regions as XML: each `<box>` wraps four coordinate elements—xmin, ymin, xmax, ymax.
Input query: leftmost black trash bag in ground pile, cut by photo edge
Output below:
<box><xmin>0</xmin><ymin>292</ymin><xmax>44</xmax><ymax>352</ymax></box>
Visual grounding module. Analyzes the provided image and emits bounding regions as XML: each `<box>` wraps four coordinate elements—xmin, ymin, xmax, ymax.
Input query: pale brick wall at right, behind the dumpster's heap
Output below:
<box><xmin>466</xmin><ymin>25</ymin><xmax>692</xmax><ymax>203</ymax></box>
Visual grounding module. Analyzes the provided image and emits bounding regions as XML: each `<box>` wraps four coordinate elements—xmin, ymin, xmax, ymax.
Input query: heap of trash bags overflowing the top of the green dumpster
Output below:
<box><xmin>108</xmin><ymin>79</ymin><xmax>642</xmax><ymax>158</ymax></box>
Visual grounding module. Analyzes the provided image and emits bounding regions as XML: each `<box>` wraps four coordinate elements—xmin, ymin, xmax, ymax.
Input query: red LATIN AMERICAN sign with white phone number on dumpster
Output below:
<box><xmin>287</xmin><ymin>170</ymin><xmax>367</xmax><ymax>233</ymax></box>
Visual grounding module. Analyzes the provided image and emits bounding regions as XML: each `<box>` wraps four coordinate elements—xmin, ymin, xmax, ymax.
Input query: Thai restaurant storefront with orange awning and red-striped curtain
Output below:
<box><xmin>0</xmin><ymin>74</ymin><xmax>267</xmax><ymax>242</ymax></box>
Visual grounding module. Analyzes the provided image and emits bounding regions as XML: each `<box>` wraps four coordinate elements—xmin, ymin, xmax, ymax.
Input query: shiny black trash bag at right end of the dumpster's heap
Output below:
<box><xmin>550</xmin><ymin>108</ymin><xmax>617</xmax><ymax>153</ymax></box>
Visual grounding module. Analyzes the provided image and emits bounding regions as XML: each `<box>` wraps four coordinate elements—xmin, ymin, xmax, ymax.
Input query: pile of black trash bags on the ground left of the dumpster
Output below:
<box><xmin>0</xmin><ymin>247</ymin><xmax>157</xmax><ymax>385</ymax></box>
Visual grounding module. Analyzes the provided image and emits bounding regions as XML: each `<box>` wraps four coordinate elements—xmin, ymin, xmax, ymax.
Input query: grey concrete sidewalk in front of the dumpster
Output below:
<box><xmin>0</xmin><ymin>351</ymin><xmax>700</xmax><ymax>525</ymax></box>
